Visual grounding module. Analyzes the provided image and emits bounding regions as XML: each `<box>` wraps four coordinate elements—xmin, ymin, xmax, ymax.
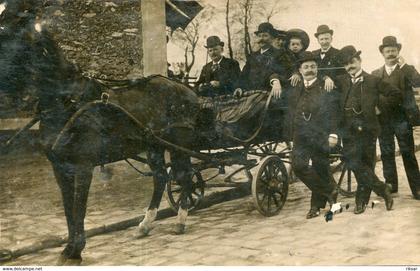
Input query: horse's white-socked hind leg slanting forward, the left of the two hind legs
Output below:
<box><xmin>138</xmin><ymin>148</ymin><xmax>168</xmax><ymax>237</ymax></box>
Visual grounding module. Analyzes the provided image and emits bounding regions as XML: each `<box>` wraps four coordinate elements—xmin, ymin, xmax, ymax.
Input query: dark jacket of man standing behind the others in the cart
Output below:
<box><xmin>312</xmin><ymin>47</ymin><xmax>346</xmax><ymax>81</ymax></box>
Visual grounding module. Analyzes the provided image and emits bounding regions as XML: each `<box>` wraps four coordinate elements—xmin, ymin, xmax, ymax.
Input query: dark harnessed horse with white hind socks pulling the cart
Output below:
<box><xmin>0</xmin><ymin>0</ymin><xmax>199</xmax><ymax>265</ymax></box>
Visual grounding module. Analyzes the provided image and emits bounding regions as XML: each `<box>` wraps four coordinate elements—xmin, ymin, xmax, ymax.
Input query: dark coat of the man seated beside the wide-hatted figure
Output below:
<box><xmin>236</xmin><ymin>47</ymin><xmax>293</xmax><ymax>90</ymax></box>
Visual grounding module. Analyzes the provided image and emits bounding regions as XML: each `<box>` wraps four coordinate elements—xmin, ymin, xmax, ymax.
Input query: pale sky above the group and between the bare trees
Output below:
<box><xmin>168</xmin><ymin>0</ymin><xmax>420</xmax><ymax>78</ymax></box>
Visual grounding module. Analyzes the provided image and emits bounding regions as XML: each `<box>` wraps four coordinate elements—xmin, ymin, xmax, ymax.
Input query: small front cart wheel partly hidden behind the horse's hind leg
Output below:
<box><xmin>165</xmin><ymin>168</ymin><xmax>205</xmax><ymax>215</ymax></box>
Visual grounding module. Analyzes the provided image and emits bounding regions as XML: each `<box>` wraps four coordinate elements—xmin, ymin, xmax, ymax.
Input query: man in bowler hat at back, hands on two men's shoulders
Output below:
<box><xmin>312</xmin><ymin>24</ymin><xmax>346</xmax><ymax>89</ymax></box>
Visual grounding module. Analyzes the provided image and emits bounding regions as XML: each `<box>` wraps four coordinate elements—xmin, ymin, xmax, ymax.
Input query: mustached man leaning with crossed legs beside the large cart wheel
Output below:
<box><xmin>288</xmin><ymin>52</ymin><xmax>339</xmax><ymax>219</ymax></box>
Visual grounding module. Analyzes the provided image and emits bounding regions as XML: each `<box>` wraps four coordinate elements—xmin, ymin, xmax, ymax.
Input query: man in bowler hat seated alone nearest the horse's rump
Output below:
<box><xmin>197</xmin><ymin>36</ymin><xmax>241</xmax><ymax>97</ymax></box>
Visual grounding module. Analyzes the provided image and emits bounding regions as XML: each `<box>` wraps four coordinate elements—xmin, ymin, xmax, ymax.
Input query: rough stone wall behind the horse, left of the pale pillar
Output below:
<box><xmin>43</xmin><ymin>0</ymin><xmax>142</xmax><ymax>79</ymax></box>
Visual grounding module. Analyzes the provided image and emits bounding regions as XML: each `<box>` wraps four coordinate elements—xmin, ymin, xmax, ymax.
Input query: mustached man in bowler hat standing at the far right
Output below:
<box><xmin>372</xmin><ymin>36</ymin><xmax>420</xmax><ymax>200</ymax></box>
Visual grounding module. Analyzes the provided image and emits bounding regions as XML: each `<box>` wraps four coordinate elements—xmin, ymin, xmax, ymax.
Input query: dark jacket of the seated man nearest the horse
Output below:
<box><xmin>196</xmin><ymin>57</ymin><xmax>241</xmax><ymax>96</ymax></box>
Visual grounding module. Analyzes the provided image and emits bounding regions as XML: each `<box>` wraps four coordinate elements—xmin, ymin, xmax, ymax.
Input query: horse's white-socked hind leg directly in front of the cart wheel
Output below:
<box><xmin>171</xmin><ymin>152</ymin><xmax>193</xmax><ymax>234</ymax></box>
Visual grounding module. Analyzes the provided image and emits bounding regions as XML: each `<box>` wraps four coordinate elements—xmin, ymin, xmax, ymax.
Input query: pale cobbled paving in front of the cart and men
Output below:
<box><xmin>4</xmin><ymin>153</ymin><xmax>420</xmax><ymax>265</ymax></box>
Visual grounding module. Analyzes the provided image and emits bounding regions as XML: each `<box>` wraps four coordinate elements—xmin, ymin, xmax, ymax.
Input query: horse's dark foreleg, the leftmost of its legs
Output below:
<box><xmin>51</xmin><ymin>161</ymin><xmax>75</xmax><ymax>265</ymax></box>
